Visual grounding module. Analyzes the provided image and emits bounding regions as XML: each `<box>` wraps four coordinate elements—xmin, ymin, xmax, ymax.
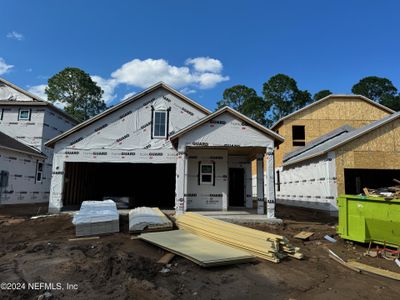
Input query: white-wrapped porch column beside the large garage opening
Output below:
<box><xmin>175</xmin><ymin>148</ymin><xmax>187</xmax><ymax>214</ymax></box>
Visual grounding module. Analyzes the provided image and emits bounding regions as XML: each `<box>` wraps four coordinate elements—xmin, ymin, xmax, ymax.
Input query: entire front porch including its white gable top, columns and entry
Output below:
<box><xmin>170</xmin><ymin>107</ymin><xmax>283</xmax><ymax>219</ymax></box>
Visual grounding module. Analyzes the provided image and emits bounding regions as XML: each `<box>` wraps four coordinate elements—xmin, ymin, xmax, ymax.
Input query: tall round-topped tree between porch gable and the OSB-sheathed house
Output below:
<box><xmin>263</xmin><ymin>74</ymin><xmax>311</xmax><ymax>122</ymax></box>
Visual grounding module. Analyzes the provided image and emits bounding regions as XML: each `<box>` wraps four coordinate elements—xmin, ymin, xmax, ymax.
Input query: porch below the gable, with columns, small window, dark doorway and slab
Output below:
<box><xmin>176</xmin><ymin>146</ymin><xmax>275</xmax><ymax>218</ymax></box>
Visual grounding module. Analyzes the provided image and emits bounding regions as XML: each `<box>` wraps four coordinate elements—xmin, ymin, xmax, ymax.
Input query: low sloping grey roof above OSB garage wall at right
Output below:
<box><xmin>283</xmin><ymin>112</ymin><xmax>400</xmax><ymax>166</ymax></box>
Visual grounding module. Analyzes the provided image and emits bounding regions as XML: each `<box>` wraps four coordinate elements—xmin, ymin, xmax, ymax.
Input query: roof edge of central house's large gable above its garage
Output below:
<box><xmin>46</xmin><ymin>82</ymin><xmax>211</xmax><ymax>148</ymax></box>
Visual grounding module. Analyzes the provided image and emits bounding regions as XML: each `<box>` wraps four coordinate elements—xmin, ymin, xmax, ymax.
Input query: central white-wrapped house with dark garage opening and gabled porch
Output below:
<box><xmin>47</xmin><ymin>83</ymin><xmax>283</xmax><ymax>217</ymax></box>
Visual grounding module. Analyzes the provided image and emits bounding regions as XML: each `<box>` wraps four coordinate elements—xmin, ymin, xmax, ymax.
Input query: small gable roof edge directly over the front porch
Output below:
<box><xmin>170</xmin><ymin>106</ymin><xmax>285</xmax><ymax>144</ymax></box>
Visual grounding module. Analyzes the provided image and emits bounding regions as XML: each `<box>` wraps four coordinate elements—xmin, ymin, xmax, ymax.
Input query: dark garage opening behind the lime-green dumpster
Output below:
<box><xmin>344</xmin><ymin>169</ymin><xmax>400</xmax><ymax>195</ymax></box>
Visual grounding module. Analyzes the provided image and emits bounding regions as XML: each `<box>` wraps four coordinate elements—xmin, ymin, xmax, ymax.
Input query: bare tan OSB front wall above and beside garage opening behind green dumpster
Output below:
<box><xmin>336</xmin><ymin>119</ymin><xmax>400</xmax><ymax>195</ymax></box>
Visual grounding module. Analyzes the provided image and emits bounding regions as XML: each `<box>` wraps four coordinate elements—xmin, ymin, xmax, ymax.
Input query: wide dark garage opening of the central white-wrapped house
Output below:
<box><xmin>63</xmin><ymin>162</ymin><xmax>175</xmax><ymax>209</ymax></box>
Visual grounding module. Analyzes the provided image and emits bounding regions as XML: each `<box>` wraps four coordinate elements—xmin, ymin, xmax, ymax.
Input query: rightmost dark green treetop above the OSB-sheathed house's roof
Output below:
<box><xmin>351</xmin><ymin>76</ymin><xmax>400</xmax><ymax>110</ymax></box>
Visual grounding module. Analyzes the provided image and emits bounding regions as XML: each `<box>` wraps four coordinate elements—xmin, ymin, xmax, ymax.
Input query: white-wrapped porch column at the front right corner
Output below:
<box><xmin>264</xmin><ymin>147</ymin><xmax>275</xmax><ymax>219</ymax></box>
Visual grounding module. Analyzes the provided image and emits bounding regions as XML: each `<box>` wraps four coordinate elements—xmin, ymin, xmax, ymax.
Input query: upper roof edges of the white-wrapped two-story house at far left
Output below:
<box><xmin>0</xmin><ymin>77</ymin><xmax>79</xmax><ymax>124</ymax></box>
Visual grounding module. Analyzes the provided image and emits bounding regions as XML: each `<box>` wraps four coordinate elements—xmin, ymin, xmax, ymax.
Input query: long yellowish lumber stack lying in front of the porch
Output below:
<box><xmin>176</xmin><ymin>213</ymin><xmax>303</xmax><ymax>263</ymax></box>
